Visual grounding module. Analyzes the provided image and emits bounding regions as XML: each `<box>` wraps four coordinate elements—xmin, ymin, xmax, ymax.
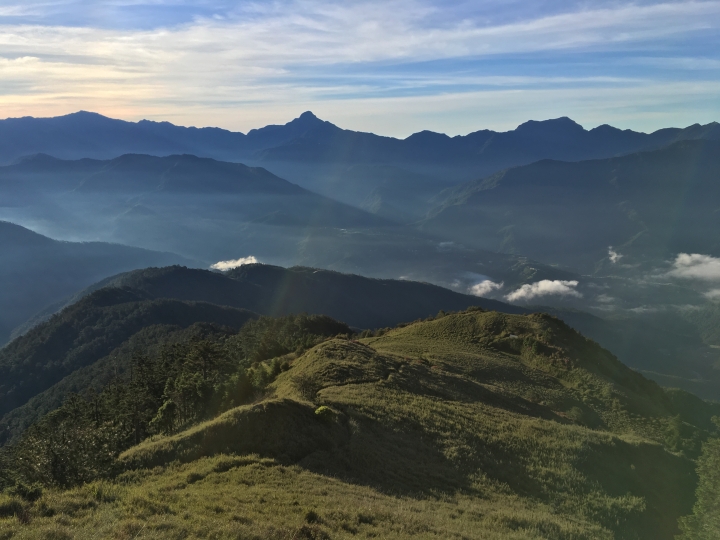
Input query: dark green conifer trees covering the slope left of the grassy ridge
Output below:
<box><xmin>0</xmin><ymin>315</ymin><xmax>351</xmax><ymax>488</ymax></box>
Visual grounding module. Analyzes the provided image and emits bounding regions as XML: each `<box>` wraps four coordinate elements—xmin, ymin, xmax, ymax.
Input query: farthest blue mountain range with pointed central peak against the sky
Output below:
<box><xmin>0</xmin><ymin>112</ymin><xmax>720</xmax><ymax>221</ymax></box>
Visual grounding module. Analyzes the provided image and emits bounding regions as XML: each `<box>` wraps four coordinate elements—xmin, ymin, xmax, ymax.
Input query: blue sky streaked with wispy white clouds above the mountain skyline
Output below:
<box><xmin>0</xmin><ymin>0</ymin><xmax>720</xmax><ymax>137</ymax></box>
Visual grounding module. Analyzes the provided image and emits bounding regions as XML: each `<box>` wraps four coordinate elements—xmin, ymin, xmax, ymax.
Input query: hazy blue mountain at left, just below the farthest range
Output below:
<box><xmin>0</xmin><ymin>154</ymin><xmax>395</xmax><ymax>264</ymax></box>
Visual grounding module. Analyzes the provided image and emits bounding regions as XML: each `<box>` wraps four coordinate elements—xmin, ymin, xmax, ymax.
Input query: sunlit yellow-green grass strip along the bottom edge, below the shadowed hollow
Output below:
<box><xmin>0</xmin><ymin>455</ymin><xmax>610</xmax><ymax>540</ymax></box>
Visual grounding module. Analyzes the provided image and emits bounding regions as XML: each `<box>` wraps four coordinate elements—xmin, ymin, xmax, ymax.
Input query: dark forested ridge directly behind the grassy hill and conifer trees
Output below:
<box><xmin>0</xmin><ymin>265</ymin><xmax>525</xmax><ymax>446</ymax></box>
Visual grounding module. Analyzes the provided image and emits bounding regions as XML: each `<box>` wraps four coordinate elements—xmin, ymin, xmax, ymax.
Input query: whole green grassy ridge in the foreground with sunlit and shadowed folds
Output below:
<box><xmin>0</xmin><ymin>311</ymin><xmax>716</xmax><ymax>540</ymax></box>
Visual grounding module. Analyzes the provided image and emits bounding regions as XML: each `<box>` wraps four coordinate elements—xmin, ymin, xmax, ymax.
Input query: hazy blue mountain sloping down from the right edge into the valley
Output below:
<box><xmin>421</xmin><ymin>140</ymin><xmax>720</xmax><ymax>273</ymax></box>
